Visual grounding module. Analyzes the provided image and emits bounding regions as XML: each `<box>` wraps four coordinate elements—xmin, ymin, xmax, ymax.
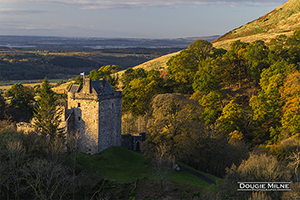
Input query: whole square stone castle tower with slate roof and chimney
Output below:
<box><xmin>66</xmin><ymin>78</ymin><xmax>122</xmax><ymax>154</ymax></box>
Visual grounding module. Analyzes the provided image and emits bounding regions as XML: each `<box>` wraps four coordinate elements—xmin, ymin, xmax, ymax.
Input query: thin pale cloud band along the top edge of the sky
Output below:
<box><xmin>0</xmin><ymin>0</ymin><xmax>285</xmax><ymax>9</ymax></box>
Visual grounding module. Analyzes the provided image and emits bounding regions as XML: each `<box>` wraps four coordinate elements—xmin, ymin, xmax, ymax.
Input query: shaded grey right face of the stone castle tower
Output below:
<box><xmin>98</xmin><ymin>93</ymin><xmax>122</xmax><ymax>152</ymax></box>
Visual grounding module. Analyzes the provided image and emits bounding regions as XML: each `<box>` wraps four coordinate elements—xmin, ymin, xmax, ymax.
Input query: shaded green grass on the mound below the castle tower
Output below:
<box><xmin>78</xmin><ymin>147</ymin><xmax>222</xmax><ymax>188</ymax></box>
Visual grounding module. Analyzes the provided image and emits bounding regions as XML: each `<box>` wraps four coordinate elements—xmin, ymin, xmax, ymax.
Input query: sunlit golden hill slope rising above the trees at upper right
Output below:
<box><xmin>212</xmin><ymin>0</ymin><xmax>300</xmax><ymax>49</ymax></box>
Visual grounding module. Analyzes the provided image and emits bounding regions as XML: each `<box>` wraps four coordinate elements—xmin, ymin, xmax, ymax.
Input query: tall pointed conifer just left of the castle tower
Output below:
<box><xmin>34</xmin><ymin>77</ymin><xmax>64</xmax><ymax>141</ymax></box>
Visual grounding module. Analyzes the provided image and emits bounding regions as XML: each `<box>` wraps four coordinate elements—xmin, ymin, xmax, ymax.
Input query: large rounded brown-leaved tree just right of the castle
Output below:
<box><xmin>143</xmin><ymin>94</ymin><xmax>203</xmax><ymax>165</ymax></box>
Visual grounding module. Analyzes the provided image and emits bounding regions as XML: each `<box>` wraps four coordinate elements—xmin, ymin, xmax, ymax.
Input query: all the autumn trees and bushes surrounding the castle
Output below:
<box><xmin>0</xmin><ymin>31</ymin><xmax>300</xmax><ymax>199</ymax></box>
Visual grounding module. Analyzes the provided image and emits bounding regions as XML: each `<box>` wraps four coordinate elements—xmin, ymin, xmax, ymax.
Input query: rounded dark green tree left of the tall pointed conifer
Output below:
<box><xmin>5</xmin><ymin>83</ymin><xmax>35</xmax><ymax>113</ymax></box>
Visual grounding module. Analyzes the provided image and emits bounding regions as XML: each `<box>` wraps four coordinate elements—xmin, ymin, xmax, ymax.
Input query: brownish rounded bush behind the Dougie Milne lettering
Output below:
<box><xmin>220</xmin><ymin>153</ymin><xmax>291</xmax><ymax>199</ymax></box>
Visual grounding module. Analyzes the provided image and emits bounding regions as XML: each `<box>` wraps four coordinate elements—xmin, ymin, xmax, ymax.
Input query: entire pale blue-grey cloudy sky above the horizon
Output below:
<box><xmin>0</xmin><ymin>0</ymin><xmax>286</xmax><ymax>39</ymax></box>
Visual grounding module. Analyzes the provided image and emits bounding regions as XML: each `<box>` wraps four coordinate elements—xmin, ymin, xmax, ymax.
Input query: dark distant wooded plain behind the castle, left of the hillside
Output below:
<box><xmin>0</xmin><ymin>47</ymin><xmax>182</xmax><ymax>82</ymax></box>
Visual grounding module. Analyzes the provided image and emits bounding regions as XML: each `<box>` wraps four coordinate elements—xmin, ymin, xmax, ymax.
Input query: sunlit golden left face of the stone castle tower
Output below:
<box><xmin>68</xmin><ymin>94</ymin><xmax>99</xmax><ymax>154</ymax></box>
